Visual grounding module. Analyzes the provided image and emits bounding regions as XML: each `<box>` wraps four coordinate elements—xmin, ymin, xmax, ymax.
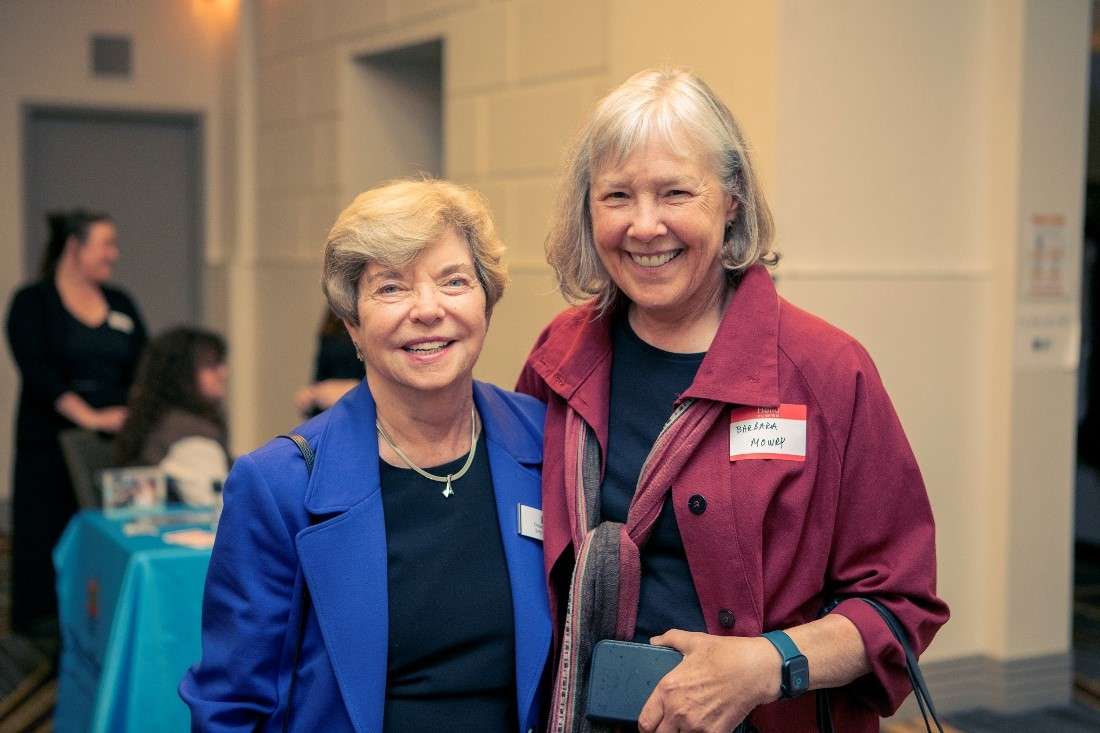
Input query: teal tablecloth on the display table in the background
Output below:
<box><xmin>54</xmin><ymin>511</ymin><xmax>210</xmax><ymax>733</ymax></box>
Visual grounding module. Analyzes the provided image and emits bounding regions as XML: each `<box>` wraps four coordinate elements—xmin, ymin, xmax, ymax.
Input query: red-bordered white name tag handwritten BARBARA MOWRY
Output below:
<box><xmin>729</xmin><ymin>405</ymin><xmax>806</xmax><ymax>461</ymax></box>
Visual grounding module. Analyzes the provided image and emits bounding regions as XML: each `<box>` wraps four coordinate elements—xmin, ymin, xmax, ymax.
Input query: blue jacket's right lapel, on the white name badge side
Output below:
<box><xmin>474</xmin><ymin>383</ymin><xmax>550</xmax><ymax>730</ymax></box>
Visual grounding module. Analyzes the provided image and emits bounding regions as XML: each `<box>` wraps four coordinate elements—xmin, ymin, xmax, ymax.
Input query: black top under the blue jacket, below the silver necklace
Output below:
<box><xmin>378</xmin><ymin>436</ymin><xmax>518</xmax><ymax>732</ymax></box>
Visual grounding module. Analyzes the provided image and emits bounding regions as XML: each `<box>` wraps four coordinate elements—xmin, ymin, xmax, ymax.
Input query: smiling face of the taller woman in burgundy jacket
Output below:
<box><xmin>589</xmin><ymin>140</ymin><xmax>737</xmax><ymax>318</ymax></box>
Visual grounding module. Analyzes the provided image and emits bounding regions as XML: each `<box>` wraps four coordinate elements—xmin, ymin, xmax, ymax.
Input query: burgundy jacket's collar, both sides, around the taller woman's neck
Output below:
<box><xmin>530</xmin><ymin>265</ymin><xmax>779</xmax><ymax>407</ymax></box>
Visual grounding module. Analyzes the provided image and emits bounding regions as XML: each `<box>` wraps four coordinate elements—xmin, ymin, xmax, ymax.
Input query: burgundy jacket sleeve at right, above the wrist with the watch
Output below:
<box><xmin>828</xmin><ymin>344</ymin><xmax>948</xmax><ymax>715</ymax></box>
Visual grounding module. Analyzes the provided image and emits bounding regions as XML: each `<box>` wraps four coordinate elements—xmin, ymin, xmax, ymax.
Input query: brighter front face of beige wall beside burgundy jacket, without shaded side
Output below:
<box><xmin>774</xmin><ymin>2</ymin><xmax>990</xmax><ymax>658</ymax></box>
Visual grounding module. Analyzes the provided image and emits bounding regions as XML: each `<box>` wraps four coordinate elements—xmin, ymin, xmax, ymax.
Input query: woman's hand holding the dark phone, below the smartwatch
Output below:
<box><xmin>638</xmin><ymin>630</ymin><xmax>780</xmax><ymax>733</ymax></box>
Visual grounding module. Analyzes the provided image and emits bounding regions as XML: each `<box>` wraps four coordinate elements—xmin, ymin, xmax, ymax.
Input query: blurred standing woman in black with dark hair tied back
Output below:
<box><xmin>8</xmin><ymin>209</ymin><xmax>145</xmax><ymax>636</ymax></box>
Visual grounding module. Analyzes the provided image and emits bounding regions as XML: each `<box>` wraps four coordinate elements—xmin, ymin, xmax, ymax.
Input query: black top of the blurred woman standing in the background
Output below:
<box><xmin>8</xmin><ymin>281</ymin><xmax>147</xmax><ymax>440</ymax></box>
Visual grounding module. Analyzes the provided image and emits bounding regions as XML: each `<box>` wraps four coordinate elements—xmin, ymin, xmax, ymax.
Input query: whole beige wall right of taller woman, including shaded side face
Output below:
<box><xmin>773</xmin><ymin>0</ymin><xmax>1090</xmax><ymax>659</ymax></box>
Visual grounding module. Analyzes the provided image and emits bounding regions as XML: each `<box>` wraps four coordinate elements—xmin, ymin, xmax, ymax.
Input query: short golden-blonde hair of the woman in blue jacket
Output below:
<box><xmin>321</xmin><ymin>178</ymin><xmax>508</xmax><ymax>326</ymax></box>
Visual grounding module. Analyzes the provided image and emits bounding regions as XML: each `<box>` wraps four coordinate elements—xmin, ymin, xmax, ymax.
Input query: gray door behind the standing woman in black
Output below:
<box><xmin>23</xmin><ymin>108</ymin><xmax>202</xmax><ymax>331</ymax></box>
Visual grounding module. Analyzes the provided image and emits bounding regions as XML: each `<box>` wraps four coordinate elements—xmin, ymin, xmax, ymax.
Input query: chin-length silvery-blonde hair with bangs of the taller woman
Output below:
<box><xmin>546</xmin><ymin>68</ymin><xmax>779</xmax><ymax>309</ymax></box>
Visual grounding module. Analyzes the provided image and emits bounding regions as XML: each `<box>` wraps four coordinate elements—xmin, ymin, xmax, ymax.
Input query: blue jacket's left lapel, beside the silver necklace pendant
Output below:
<box><xmin>296</xmin><ymin>380</ymin><xmax>389</xmax><ymax>733</ymax></box>
